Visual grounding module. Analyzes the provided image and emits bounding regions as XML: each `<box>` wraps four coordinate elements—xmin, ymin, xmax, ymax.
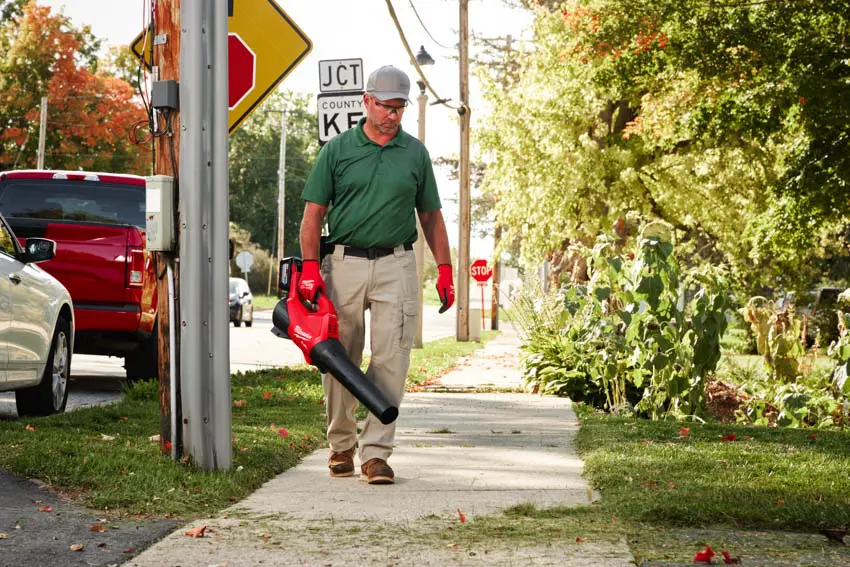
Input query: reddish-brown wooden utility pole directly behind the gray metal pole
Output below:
<box><xmin>148</xmin><ymin>0</ymin><xmax>183</xmax><ymax>460</ymax></box>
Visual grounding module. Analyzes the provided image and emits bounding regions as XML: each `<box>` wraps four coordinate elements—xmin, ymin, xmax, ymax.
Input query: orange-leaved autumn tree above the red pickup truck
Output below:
<box><xmin>0</xmin><ymin>1</ymin><xmax>150</xmax><ymax>174</ymax></box>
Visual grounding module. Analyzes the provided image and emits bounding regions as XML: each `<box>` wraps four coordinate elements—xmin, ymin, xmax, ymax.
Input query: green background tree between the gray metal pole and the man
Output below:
<box><xmin>230</xmin><ymin>92</ymin><xmax>319</xmax><ymax>256</ymax></box>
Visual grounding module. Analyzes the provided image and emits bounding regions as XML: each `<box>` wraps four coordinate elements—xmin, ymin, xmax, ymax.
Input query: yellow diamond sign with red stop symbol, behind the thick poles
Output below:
<box><xmin>130</xmin><ymin>0</ymin><xmax>313</xmax><ymax>134</ymax></box>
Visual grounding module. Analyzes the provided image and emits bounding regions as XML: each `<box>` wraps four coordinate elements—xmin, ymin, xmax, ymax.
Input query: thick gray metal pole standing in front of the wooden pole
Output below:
<box><xmin>179</xmin><ymin>0</ymin><xmax>232</xmax><ymax>470</ymax></box>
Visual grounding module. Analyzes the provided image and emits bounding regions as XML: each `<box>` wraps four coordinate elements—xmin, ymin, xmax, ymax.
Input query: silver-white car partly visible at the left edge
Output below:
<box><xmin>0</xmin><ymin>215</ymin><xmax>74</xmax><ymax>416</ymax></box>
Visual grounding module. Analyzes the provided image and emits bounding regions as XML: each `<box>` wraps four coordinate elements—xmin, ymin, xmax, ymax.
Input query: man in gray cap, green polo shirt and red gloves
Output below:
<box><xmin>298</xmin><ymin>66</ymin><xmax>454</xmax><ymax>484</ymax></box>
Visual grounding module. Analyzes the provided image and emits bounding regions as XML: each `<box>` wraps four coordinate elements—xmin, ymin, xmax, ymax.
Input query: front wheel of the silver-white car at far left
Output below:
<box><xmin>15</xmin><ymin>317</ymin><xmax>71</xmax><ymax>417</ymax></box>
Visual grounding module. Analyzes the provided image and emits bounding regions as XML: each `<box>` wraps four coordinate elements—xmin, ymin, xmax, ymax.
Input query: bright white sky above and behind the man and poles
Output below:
<box><xmin>38</xmin><ymin>0</ymin><xmax>532</xmax><ymax>258</ymax></box>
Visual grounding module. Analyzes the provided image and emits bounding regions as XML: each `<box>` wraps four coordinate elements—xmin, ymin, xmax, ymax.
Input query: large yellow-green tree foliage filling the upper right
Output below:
<box><xmin>480</xmin><ymin>0</ymin><xmax>850</xmax><ymax>296</ymax></box>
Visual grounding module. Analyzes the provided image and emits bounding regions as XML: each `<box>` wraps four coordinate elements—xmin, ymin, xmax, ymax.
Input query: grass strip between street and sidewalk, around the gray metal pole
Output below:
<box><xmin>0</xmin><ymin>332</ymin><xmax>496</xmax><ymax>520</ymax></box>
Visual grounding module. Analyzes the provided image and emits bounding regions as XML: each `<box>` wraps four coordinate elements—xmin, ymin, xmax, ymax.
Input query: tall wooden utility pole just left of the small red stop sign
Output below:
<box><xmin>457</xmin><ymin>0</ymin><xmax>471</xmax><ymax>341</ymax></box>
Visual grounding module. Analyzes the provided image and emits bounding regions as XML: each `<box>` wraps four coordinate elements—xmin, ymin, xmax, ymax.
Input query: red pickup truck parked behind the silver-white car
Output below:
<box><xmin>0</xmin><ymin>171</ymin><xmax>157</xmax><ymax>380</ymax></box>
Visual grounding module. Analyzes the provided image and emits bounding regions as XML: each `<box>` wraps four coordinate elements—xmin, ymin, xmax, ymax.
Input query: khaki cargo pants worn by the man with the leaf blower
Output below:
<box><xmin>322</xmin><ymin>245</ymin><xmax>419</xmax><ymax>463</ymax></box>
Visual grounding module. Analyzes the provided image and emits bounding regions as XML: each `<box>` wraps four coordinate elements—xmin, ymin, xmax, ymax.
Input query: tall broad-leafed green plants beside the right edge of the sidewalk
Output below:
<box><xmin>514</xmin><ymin>223</ymin><xmax>729</xmax><ymax>419</ymax></box>
